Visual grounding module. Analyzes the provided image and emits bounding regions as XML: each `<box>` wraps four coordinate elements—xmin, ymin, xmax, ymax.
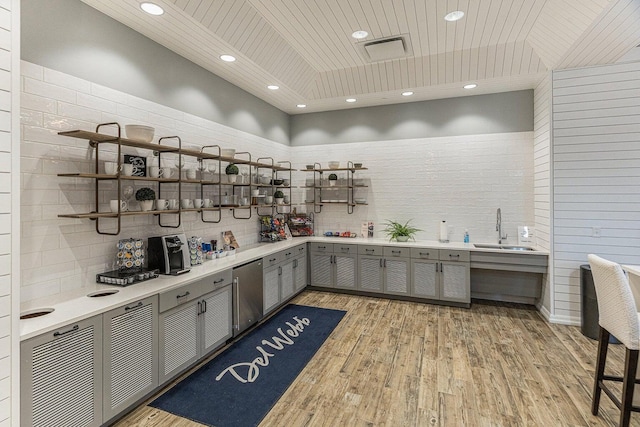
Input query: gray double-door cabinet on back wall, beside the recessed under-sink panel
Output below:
<box><xmin>411</xmin><ymin>248</ymin><xmax>471</xmax><ymax>304</ymax></box>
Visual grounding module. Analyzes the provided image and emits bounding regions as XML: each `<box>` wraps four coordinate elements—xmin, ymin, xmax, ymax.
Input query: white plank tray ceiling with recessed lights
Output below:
<box><xmin>83</xmin><ymin>0</ymin><xmax>640</xmax><ymax>114</ymax></box>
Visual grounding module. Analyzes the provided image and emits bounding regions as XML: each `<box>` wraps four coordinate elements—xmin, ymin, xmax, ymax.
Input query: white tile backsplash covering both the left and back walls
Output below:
<box><xmin>20</xmin><ymin>61</ymin><xmax>534</xmax><ymax>301</ymax></box>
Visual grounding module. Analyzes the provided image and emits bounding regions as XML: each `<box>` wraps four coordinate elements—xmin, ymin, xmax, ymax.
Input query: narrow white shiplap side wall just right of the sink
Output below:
<box><xmin>533</xmin><ymin>73</ymin><xmax>553</xmax><ymax>317</ymax></box>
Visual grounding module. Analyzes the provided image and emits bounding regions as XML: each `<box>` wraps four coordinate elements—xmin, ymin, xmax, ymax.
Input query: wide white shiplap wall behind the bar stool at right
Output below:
<box><xmin>553</xmin><ymin>62</ymin><xmax>640</xmax><ymax>323</ymax></box>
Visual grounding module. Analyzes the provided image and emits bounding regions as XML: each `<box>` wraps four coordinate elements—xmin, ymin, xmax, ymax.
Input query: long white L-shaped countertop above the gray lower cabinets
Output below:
<box><xmin>20</xmin><ymin>237</ymin><xmax>548</xmax><ymax>340</ymax></box>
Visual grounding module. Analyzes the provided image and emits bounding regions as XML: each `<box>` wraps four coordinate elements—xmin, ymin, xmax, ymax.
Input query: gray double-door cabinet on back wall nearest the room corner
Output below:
<box><xmin>309</xmin><ymin>243</ymin><xmax>358</xmax><ymax>289</ymax></box>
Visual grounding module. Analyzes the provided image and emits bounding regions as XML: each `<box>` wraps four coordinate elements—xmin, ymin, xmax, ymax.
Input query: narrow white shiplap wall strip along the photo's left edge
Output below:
<box><xmin>0</xmin><ymin>0</ymin><xmax>20</xmax><ymax>427</ymax></box>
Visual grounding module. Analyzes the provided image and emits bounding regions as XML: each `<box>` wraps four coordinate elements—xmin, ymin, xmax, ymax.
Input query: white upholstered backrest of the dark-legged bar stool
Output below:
<box><xmin>588</xmin><ymin>254</ymin><xmax>640</xmax><ymax>350</ymax></box>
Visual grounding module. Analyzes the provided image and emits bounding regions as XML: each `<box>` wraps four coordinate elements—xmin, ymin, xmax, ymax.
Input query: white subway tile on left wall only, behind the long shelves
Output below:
<box><xmin>21</xmin><ymin>61</ymin><xmax>290</xmax><ymax>301</ymax></box>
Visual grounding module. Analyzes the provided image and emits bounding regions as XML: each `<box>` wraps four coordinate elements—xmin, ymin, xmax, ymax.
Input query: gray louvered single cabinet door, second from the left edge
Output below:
<box><xmin>102</xmin><ymin>295</ymin><xmax>158</xmax><ymax>422</ymax></box>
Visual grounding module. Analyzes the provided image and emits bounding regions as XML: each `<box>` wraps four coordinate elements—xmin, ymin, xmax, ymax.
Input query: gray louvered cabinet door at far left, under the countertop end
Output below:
<box><xmin>20</xmin><ymin>315</ymin><xmax>102</xmax><ymax>427</ymax></box>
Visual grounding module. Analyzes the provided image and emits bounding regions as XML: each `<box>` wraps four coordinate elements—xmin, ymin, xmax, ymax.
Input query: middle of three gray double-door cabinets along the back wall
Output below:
<box><xmin>358</xmin><ymin>245</ymin><xmax>411</xmax><ymax>295</ymax></box>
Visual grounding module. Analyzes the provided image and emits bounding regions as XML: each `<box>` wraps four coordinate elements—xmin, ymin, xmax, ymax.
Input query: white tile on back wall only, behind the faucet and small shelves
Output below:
<box><xmin>292</xmin><ymin>132</ymin><xmax>534</xmax><ymax>243</ymax></box>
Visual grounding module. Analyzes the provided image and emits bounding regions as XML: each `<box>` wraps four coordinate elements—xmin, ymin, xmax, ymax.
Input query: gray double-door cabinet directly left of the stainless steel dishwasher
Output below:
<box><xmin>158</xmin><ymin>270</ymin><xmax>233</xmax><ymax>384</ymax></box>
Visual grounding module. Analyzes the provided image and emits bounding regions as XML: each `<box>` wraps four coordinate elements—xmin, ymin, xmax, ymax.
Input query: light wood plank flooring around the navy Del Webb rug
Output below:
<box><xmin>117</xmin><ymin>291</ymin><xmax>640</xmax><ymax>427</ymax></box>
